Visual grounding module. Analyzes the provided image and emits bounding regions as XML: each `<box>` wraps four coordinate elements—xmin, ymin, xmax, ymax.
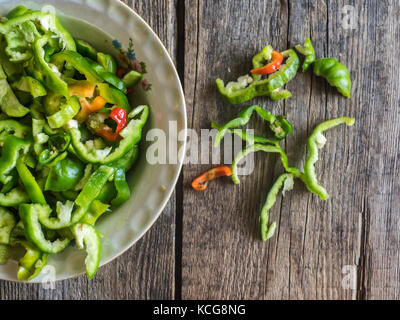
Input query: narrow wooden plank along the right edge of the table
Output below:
<box><xmin>358</xmin><ymin>1</ymin><xmax>400</xmax><ymax>300</ymax></box>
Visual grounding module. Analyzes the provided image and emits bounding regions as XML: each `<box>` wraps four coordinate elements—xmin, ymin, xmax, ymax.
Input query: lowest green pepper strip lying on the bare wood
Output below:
<box><xmin>260</xmin><ymin>173</ymin><xmax>295</xmax><ymax>242</ymax></box>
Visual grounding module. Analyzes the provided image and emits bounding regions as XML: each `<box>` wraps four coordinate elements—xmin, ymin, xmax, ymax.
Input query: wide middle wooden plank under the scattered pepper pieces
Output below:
<box><xmin>182</xmin><ymin>0</ymin><xmax>373</xmax><ymax>299</ymax></box>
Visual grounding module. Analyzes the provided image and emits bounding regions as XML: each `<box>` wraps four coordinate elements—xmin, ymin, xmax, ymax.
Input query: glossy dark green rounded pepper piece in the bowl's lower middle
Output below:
<box><xmin>45</xmin><ymin>157</ymin><xmax>84</xmax><ymax>192</ymax></box>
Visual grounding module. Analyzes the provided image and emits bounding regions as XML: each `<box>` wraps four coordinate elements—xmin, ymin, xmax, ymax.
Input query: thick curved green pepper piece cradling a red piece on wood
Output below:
<box><xmin>216</xmin><ymin>49</ymin><xmax>300</xmax><ymax>104</ymax></box>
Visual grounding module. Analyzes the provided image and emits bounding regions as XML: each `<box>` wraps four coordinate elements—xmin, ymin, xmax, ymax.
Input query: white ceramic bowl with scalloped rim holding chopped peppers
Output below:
<box><xmin>0</xmin><ymin>0</ymin><xmax>187</xmax><ymax>282</ymax></box>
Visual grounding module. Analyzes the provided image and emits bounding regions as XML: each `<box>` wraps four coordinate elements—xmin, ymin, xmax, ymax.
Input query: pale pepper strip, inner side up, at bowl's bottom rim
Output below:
<box><xmin>72</xmin><ymin>223</ymin><xmax>101</xmax><ymax>280</ymax></box>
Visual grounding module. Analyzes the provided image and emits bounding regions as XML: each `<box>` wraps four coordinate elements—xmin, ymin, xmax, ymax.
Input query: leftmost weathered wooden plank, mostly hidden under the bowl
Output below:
<box><xmin>0</xmin><ymin>0</ymin><xmax>176</xmax><ymax>300</ymax></box>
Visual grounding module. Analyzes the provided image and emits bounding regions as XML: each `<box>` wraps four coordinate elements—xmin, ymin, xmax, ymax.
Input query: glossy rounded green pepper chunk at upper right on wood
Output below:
<box><xmin>314</xmin><ymin>58</ymin><xmax>352</xmax><ymax>98</ymax></box>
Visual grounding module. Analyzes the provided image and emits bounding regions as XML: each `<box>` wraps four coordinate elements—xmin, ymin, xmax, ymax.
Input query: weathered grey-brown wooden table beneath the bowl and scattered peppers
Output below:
<box><xmin>0</xmin><ymin>0</ymin><xmax>400</xmax><ymax>299</ymax></box>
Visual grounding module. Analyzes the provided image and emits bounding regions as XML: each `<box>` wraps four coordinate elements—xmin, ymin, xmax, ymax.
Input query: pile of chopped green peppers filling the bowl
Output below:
<box><xmin>0</xmin><ymin>6</ymin><xmax>149</xmax><ymax>280</ymax></box>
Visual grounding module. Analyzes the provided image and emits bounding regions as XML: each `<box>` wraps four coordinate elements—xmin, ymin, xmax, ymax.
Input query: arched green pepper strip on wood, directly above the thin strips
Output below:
<box><xmin>215</xmin><ymin>105</ymin><xmax>293</xmax><ymax>147</ymax></box>
